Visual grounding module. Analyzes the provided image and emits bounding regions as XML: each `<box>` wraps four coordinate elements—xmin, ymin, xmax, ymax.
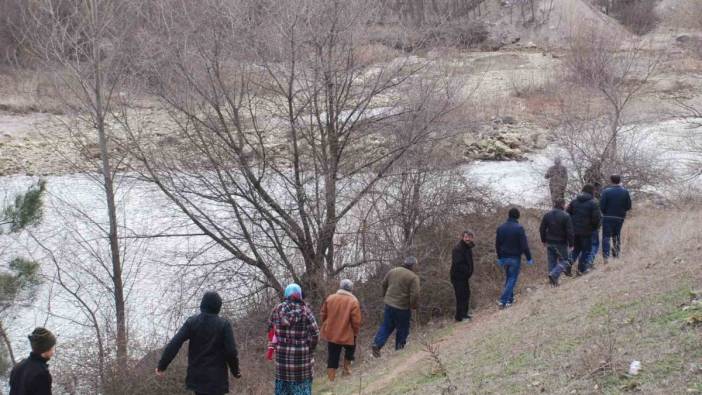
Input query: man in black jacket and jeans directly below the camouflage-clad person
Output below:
<box><xmin>539</xmin><ymin>199</ymin><xmax>575</xmax><ymax>287</ymax></box>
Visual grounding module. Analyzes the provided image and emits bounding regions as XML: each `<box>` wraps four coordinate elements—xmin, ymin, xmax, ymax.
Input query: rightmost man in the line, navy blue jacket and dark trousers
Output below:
<box><xmin>600</xmin><ymin>175</ymin><xmax>631</xmax><ymax>262</ymax></box>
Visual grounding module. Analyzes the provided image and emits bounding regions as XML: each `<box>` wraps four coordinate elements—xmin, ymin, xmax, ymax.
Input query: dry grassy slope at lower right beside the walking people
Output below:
<box><xmin>315</xmin><ymin>210</ymin><xmax>702</xmax><ymax>394</ymax></box>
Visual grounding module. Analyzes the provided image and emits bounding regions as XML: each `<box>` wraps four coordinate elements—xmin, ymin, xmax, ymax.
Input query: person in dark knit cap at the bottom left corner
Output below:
<box><xmin>10</xmin><ymin>328</ymin><xmax>56</xmax><ymax>395</ymax></box>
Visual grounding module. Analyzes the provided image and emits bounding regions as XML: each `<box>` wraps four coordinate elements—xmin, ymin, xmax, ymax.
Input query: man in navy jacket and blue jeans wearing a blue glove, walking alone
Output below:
<box><xmin>495</xmin><ymin>208</ymin><xmax>534</xmax><ymax>309</ymax></box>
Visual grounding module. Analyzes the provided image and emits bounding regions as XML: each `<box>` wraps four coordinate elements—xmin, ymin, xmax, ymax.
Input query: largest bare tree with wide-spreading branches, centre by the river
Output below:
<box><xmin>129</xmin><ymin>0</ymin><xmax>462</xmax><ymax>295</ymax></box>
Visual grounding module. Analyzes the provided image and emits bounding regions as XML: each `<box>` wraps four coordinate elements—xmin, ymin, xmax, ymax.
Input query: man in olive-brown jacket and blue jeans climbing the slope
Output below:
<box><xmin>373</xmin><ymin>256</ymin><xmax>419</xmax><ymax>358</ymax></box>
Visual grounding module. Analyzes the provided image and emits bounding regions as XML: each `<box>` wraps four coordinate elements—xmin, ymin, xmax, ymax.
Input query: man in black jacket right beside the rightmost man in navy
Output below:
<box><xmin>567</xmin><ymin>184</ymin><xmax>602</xmax><ymax>274</ymax></box>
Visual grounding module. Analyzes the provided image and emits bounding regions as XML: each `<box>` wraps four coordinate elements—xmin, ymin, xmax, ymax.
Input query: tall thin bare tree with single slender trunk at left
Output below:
<box><xmin>24</xmin><ymin>0</ymin><xmax>142</xmax><ymax>376</ymax></box>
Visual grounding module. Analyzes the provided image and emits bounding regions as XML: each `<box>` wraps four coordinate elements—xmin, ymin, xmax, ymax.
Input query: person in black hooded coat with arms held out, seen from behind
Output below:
<box><xmin>156</xmin><ymin>292</ymin><xmax>241</xmax><ymax>395</ymax></box>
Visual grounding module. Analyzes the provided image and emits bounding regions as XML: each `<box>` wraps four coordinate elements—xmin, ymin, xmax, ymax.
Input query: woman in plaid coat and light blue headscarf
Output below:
<box><xmin>269</xmin><ymin>284</ymin><xmax>319</xmax><ymax>395</ymax></box>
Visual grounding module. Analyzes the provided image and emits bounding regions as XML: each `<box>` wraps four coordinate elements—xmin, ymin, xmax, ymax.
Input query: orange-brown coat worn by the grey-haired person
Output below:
<box><xmin>321</xmin><ymin>290</ymin><xmax>361</xmax><ymax>345</ymax></box>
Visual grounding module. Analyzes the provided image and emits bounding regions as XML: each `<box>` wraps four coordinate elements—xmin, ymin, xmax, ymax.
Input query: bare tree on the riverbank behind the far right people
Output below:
<box><xmin>553</xmin><ymin>27</ymin><xmax>658</xmax><ymax>184</ymax></box>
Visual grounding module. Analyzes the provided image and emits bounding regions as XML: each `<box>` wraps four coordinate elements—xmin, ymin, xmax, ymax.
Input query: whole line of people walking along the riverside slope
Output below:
<box><xmin>10</xmin><ymin>160</ymin><xmax>631</xmax><ymax>395</ymax></box>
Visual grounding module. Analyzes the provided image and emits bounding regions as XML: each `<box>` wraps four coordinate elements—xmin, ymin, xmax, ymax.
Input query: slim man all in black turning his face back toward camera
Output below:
<box><xmin>451</xmin><ymin>230</ymin><xmax>475</xmax><ymax>322</ymax></box>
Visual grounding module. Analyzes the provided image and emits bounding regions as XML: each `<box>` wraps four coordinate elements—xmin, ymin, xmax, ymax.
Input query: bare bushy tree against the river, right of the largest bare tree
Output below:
<box><xmin>353</xmin><ymin>131</ymin><xmax>487</xmax><ymax>263</ymax></box>
